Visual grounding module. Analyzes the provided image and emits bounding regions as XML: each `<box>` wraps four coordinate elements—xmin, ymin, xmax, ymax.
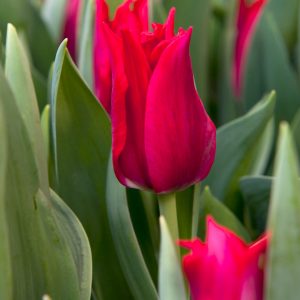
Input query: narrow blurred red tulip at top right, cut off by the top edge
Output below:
<box><xmin>232</xmin><ymin>0</ymin><xmax>267</xmax><ymax>97</ymax></box>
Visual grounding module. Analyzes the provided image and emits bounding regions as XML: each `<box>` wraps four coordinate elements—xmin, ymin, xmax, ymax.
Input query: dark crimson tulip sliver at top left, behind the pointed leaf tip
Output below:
<box><xmin>63</xmin><ymin>0</ymin><xmax>80</xmax><ymax>61</ymax></box>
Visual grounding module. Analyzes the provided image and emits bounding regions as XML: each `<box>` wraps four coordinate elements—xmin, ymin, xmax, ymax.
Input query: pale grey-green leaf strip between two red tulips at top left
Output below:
<box><xmin>78</xmin><ymin>0</ymin><xmax>95</xmax><ymax>88</ymax></box>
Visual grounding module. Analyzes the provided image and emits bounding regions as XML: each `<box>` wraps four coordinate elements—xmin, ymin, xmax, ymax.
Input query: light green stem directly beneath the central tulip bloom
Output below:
<box><xmin>158</xmin><ymin>193</ymin><xmax>179</xmax><ymax>242</ymax></box>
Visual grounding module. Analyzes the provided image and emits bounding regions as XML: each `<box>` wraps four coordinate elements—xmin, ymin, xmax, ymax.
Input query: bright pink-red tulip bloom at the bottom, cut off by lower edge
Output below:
<box><xmin>179</xmin><ymin>217</ymin><xmax>267</xmax><ymax>300</ymax></box>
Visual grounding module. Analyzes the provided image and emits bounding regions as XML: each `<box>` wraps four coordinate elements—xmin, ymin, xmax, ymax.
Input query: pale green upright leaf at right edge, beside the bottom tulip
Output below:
<box><xmin>265</xmin><ymin>123</ymin><xmax>300</xmax><ymax>300</ymax></box>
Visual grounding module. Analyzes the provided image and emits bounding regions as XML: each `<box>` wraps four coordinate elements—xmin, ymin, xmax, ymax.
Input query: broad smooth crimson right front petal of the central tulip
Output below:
<box><xmin>145</xmin><ymin>29</ymin><xmax>215</xmax><ymax>193</ymax></box>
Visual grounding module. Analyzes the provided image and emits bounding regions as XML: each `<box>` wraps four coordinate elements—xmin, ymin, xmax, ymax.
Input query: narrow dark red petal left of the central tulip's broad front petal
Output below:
<box><xmin>119</xmin><ymin>31</ymin><xmax>151</xmax><ymax>187</ymax></box>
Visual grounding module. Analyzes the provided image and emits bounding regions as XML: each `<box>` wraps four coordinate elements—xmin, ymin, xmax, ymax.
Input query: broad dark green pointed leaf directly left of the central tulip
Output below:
<box><xmin>50</xmin><ymin>42</ymin><xmax>131</xmax><ymax>299</ymax></box>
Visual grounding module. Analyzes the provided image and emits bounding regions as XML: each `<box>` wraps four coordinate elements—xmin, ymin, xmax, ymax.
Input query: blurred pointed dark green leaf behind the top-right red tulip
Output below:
<box><xmin>243</xmin><ymin>11</ymin><xmax>300</xmax><ymax>123</ymax></box>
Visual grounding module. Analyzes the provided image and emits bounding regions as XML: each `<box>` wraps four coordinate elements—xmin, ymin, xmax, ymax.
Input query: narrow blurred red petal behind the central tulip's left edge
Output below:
<box><xmin>93</xmin><ymin>0</ymin><xmax>112</xmax><ymax>114</ymax></box>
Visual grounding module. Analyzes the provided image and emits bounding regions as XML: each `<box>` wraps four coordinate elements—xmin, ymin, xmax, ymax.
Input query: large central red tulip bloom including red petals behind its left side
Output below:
<box><xmin>94</xmin><ymin>0</ymin><xmax>216</xmax><ymax>193</ymax></box>
